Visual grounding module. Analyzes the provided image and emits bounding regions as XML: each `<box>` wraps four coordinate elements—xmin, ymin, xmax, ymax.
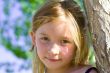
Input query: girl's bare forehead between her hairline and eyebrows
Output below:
<box><xmin>38</xmin><ymin>20</ymin><xmax>73</xmax><ymax>37</ymax></box>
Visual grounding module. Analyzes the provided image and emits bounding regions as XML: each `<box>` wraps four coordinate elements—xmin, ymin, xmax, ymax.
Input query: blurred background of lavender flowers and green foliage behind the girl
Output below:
<box><xmin>0</xmin><ymin>0</ymin><xmax>95</xmax><ymax>73</ymax></box>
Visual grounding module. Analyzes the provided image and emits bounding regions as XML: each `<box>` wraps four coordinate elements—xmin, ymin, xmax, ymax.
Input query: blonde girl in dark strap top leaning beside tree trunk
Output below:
<box><xmin>31</xmin><ymin>0</ymin><xmax>97</xmax><ymax>73</ymax></box>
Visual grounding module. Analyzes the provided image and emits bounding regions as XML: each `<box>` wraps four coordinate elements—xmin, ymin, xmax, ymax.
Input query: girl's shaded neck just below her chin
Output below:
<box><xmin>47</xmin><ymin>65</ymin><xmax>72</xmax><ymax>73</ymax></box>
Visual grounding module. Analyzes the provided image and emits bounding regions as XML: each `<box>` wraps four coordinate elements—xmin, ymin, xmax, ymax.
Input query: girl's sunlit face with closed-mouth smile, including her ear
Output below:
<box><xmin>31</xmin><ymin>20</ymin><xmax>76</xmax><ymax>69</ymax></box>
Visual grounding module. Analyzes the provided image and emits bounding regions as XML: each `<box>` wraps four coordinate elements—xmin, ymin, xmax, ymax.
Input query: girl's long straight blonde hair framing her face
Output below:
<box><xmin>32</xmin><ymin>0</ymin><xmax>88</xmax><ymax>73</ymax></box>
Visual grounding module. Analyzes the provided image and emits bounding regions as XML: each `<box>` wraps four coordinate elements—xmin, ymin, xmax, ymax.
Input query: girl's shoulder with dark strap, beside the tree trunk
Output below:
<box><xmin>70</xmin><ymin>65</ymin><xmax>98</xmax><ymax>73</ymax></box>
